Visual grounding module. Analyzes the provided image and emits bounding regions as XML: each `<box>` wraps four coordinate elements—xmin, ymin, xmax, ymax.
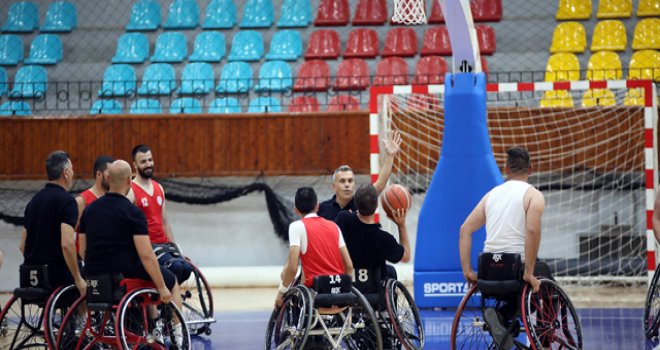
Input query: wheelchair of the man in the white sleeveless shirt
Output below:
<box><xmin>450</xmin><ymin>253</ymin><xmax>583</xmax><ymax>350</ymax></box>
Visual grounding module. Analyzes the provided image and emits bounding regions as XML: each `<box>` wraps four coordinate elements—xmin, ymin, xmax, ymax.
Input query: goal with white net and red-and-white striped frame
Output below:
<box><xmin>371</xmin><ymin>81</ymin><xmax>657</xmax><ymax>284</ymax></box>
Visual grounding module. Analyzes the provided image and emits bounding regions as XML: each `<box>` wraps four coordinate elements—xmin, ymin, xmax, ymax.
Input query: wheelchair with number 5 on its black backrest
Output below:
<box><xmin>0</xmin><ymin>265</ymin><xmax>80</xmax><ymax>350</ymax></box>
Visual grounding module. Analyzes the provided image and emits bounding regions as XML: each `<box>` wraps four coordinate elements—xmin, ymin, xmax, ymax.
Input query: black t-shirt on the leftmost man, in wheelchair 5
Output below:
<box><xmin>24</xmin><ymin>183</ymin><xmax>78</xmax><ymax>274</ymax></box>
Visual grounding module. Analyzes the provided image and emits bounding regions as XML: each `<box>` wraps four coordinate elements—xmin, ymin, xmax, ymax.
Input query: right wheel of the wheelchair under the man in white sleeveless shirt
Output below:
<box><xmin>522</xmin><ymin>279</ymin><xmax>582</xmax><ymax>350</ymax></box>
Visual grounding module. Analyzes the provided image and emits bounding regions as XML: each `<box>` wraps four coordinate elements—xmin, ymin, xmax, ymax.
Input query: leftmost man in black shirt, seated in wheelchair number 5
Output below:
<box><xmin>20</xmin><ymin>151</ymin><xmax>87</xmax><ymax>295</ymax></box>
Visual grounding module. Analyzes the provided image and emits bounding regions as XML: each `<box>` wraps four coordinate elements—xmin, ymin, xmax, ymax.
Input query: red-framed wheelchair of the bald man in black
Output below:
<box><xmin>56</xmin><ymin>275</ymin><xmax>191</xmax><ymax>350</ymax></box>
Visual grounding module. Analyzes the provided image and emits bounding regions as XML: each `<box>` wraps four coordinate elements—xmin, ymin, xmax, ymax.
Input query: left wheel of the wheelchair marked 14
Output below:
<box><xmin>265</xmin><ymin>286</ymin><xmax>313</xmax><ymax>350</ymax></box>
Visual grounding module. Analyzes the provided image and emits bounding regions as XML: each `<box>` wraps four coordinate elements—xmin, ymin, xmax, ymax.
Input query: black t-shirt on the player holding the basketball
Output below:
<box><xmin>335</xmin><ymin>211</ymin><xmax>404</xmax><ymax>273</ymax></box>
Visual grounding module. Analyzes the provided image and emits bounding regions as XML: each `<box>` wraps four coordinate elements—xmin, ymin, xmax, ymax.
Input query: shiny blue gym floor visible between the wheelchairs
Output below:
<box><xmin>193</xmin><ymin>309</ymin><xmax>658</xmax><ymax>350</ymax></box>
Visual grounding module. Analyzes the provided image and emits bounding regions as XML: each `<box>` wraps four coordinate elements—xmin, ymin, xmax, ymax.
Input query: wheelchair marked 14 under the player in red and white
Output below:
<box><xmin>265</xmin><ymin>275</ymin><xmax>383</xmax><ymax>350</ymax></box>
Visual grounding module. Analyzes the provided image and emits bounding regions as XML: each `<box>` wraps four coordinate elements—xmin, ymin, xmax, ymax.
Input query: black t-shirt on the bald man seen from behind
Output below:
<box><xmin>78</xmin><ymin>193</ymin><xmax>149</xmax><ymax>277</ymax></box>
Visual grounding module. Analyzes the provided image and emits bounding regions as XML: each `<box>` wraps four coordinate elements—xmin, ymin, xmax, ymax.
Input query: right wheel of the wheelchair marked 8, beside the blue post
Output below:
<box><xmin>385</xmin><ymin>279</ymin><xmax>424</xmax><ymax>350</ymax></box>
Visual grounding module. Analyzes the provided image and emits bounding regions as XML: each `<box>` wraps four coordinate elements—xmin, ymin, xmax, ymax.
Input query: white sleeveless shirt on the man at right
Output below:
<box><xmin>484</xmin><ymin>180</ymin><xmax>532</xmax><ymax>259</ymax></box>
